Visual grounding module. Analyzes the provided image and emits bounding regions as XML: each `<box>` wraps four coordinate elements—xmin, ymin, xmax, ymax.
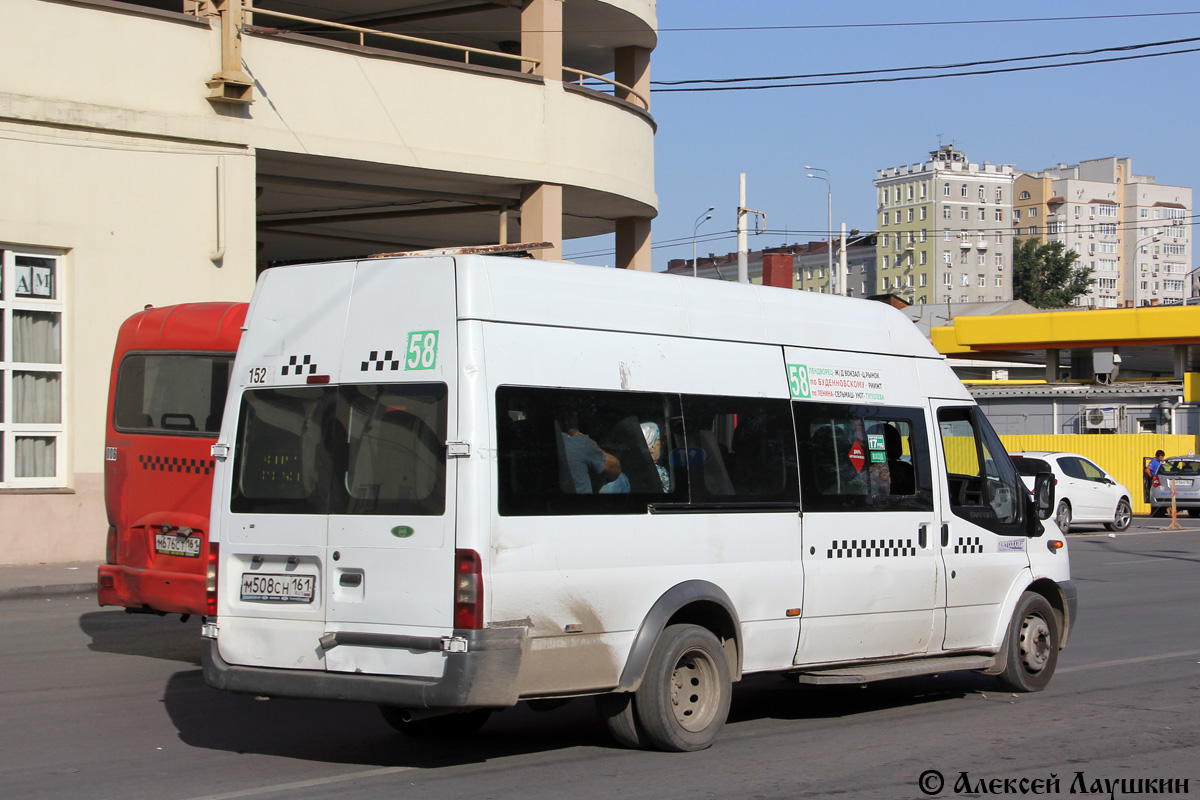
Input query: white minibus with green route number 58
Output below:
<box><xmin>203</xmin><ymin>254</ymin><xmax>1075</xmax><ymax>751</ymax></box>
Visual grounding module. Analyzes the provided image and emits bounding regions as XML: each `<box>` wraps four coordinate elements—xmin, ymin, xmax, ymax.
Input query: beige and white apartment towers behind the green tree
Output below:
<box><xmin>1012</xmin><ymin>156</ymin><xmax>1193</xmax><ymax>308</ymax></box>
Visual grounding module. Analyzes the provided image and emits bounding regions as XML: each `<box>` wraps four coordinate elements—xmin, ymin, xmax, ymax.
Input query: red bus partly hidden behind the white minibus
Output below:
<box><xmin>98</xmin><ymin>302</ymin><xmax>246</xmax><ymax>619</ymax></box>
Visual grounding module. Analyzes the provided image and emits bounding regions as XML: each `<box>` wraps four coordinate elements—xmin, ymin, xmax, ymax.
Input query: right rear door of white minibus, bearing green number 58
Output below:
<box><xmin>325</xmin><ymin>258</ymin><xmax>457</xmax><ymax>676</ymax></box>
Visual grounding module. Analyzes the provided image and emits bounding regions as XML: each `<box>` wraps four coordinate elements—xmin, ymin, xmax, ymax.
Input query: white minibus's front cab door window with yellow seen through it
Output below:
<box><xmin>937</xmin><ymin>407</ymin><xmax>1026</xmax><ymax>535</ymax></box>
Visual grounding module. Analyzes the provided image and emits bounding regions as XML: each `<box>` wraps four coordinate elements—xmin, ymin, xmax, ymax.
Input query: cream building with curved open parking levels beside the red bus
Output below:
<box><xmin>0</xmin><ymin>0</ymin><xmax>658</xmax><ymax>563</ymax></box>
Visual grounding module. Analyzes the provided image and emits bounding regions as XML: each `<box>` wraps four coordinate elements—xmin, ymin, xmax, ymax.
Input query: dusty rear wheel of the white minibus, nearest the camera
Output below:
<box><xmin>634</xmin><ymin>625</ymin><xmax>733</xmax><ymax>752</ymax></box>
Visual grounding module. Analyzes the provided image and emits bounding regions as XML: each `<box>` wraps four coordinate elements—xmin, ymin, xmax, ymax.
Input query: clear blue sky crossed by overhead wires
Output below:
<box><xmin>564</xmin><ymin>0</ymin><xmax>1200</xmax><ymax>270</ymax></box>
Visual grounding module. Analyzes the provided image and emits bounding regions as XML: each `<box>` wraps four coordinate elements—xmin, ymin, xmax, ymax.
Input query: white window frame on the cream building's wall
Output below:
<box><xmin>0</xmin><ymin>242</ymin><xmax>70</xmax><ymax>489</ymax></box>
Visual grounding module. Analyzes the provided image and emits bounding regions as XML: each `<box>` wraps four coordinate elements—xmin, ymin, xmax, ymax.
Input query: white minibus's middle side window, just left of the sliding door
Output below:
<box><xmin>686</xmin><ymin>395</ymin><xmax>799</xmax><ymax>505</ymax></box>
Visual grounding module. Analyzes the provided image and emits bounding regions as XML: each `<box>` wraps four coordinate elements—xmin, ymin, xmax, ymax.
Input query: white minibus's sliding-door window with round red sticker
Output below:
<box><xmin>792</xmin><ymin>402</ymin><xmax>934</xmax><ymax>512</ymax></box>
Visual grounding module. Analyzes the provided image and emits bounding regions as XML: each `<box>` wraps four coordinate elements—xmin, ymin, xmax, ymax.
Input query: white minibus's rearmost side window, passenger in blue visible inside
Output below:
<box><xmin>496</xmin><ymin>386</ymin><xmax>688</xmax><ymax>516</ymax></box>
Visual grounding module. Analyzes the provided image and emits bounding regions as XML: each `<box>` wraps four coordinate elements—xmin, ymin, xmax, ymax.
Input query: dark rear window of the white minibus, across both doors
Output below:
<box><xmin>230</xmin><ymin>384</ymin><xmax>448</xmax><ymax>516</ymax></box>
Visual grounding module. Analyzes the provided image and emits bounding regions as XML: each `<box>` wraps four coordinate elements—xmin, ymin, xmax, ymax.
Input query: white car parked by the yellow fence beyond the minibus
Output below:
<box><xmin>1012</xmin><ymin>451</ymin><xmax>1133</xmax><ymax>534</ymax></box>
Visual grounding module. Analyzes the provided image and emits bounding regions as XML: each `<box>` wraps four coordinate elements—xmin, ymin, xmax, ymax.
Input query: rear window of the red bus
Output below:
<box><xmin>113</xmin><ymin>353</ymin><xmax>233</xmax><ymax>437</ymax></box>
